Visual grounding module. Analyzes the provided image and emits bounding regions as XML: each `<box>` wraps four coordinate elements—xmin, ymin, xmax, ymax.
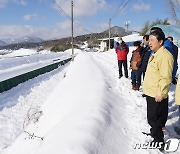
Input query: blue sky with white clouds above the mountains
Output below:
<box><xmin>0</xmin><ymin>0</ymin><xmax>180</xmax><ymax>40</ymax></box>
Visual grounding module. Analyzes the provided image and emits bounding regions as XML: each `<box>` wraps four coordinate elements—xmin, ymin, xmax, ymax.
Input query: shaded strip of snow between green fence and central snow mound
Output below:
<box><xmin>0</xmin><ymin>64</ymin><xmax>69</xmax><ymax>153</ymax></box>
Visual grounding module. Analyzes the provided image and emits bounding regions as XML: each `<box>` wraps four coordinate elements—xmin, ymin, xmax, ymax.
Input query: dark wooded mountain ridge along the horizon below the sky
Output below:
<box><xmin>0</xmin><ymin>26</ymin><xmax>132</xmax><ymax>51</ymax></box>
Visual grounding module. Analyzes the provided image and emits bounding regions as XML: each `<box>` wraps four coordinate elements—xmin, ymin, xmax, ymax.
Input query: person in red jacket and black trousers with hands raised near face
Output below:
<box><xmin>115</xmin><ymin>38</ymin><xmax>129</xmax><ymax>79</ymax></box>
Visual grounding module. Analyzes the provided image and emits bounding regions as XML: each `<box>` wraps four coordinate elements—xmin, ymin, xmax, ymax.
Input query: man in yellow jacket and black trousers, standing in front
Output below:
<box><xmin>143</xmin><ymin>30</ymin><xmax>174</xmax><ymax>146</ymax></box>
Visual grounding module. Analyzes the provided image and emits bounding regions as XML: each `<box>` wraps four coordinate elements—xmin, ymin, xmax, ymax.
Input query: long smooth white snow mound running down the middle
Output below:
<box><xmin>4</xmin><ymin>53</ymin><xmax>125</xmax><ymax>154</ymax></box>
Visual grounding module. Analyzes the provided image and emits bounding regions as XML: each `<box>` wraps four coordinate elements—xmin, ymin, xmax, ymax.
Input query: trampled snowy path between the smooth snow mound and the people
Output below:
<box><xmin>89</xmin><ymin>50</ymin><xmax>154</xmax><ymax>154</ymax></box>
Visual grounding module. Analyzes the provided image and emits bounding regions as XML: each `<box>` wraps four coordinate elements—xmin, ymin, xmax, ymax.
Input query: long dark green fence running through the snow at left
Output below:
<box><xmin>0</xmin><ymin>58</ymin><xmax>71</xmax><ymax>93</ymax></box>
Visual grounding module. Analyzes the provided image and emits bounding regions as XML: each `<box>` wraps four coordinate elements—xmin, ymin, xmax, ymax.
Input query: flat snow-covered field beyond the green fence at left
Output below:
<box><xmin>0</xmin><ymin>49</ymin><xmax>79</xmax><ymax>81</ymax></box>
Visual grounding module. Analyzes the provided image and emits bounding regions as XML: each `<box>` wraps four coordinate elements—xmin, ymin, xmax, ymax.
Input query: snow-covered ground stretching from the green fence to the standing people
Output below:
<box><xmin>0</xmin><ymin>34</ymin><xmax>180</xmax><ymax>154</ymax></box>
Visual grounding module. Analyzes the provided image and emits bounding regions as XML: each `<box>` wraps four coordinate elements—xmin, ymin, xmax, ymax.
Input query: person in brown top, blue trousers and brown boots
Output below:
<box><xmin>130</xmin><ymin>41</ymin><xmax>141</xmax><ymax>90</ymax></box>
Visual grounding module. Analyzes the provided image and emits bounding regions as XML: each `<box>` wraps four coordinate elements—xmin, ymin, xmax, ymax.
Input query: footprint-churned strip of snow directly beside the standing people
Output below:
<box><xmin>92</xmin><ymin>51</ymin><xmax>159</xmax><ymax>154</ymax></box>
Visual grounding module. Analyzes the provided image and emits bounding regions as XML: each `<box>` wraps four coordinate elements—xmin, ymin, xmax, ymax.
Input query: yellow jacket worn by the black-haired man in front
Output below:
<box><xmin>143</xmin><ymin>46</ymin><xmax>174</xmax><ymax>98</ymax></box>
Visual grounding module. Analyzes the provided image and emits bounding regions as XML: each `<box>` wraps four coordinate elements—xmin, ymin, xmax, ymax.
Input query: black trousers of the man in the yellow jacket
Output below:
<box><xmin>146</xmin><ymin>96</ymin><xmax>168</xmax><ymax>142</ymax></box>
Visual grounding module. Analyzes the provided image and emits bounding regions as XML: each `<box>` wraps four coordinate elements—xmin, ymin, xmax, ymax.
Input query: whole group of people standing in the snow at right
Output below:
<box><xmin>115</xmin><ymin>27</ymin><xmax>180</xmax><ymax>150</ymax></box>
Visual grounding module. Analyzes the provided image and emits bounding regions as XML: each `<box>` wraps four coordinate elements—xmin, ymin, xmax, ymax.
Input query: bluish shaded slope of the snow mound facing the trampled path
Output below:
<box><xmin>86</xmin><ymin>54</ymin><xmax>132</xmax><ymax>154</ymax></box>
